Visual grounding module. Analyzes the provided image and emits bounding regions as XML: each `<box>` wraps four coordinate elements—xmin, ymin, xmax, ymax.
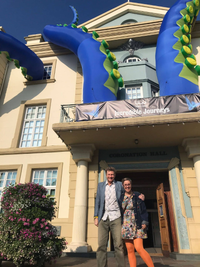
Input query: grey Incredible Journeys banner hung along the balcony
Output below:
<box><xmin>76</xmin><ymin>93</ymin><xmax>200</xmax><ymax>121</ymax></box>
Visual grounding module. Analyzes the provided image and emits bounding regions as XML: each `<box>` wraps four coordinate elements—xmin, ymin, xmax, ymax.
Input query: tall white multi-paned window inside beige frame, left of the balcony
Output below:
<box><xmin>20</xmin><ymin>105</ymin><xmax>46</xmax><ymax>147</ymax></box>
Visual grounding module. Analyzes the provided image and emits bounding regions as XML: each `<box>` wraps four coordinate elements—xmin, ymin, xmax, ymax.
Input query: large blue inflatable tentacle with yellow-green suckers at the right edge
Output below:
<box><xmin>156</xmin><ymin>0</ymin><xmax>200</xmax><ymax>96</ymax></box>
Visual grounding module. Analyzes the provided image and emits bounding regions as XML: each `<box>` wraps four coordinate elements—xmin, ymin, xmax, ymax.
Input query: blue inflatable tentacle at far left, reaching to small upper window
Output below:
<box><xmin>0</xmin><ymin>31</ymin><xmax>44</xmax><ymax>80</ymax></box>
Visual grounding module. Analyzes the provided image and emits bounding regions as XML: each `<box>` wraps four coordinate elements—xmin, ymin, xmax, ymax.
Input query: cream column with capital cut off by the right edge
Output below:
<box><xmin>182</xmin><ymin>137</ymin><xmax>200</xmax><ymax>198</ymax></box>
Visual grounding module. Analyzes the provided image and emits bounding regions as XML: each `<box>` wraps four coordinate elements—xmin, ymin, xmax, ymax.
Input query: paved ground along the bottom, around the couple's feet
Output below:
<box><xmin>2</xmin><ymin>256</ymin><xmax>200</xmax><ymax>267</ymax></box>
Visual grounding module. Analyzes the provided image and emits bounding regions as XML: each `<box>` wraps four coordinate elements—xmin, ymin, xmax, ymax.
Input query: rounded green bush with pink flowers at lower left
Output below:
<box><xmin>0</xmin><ymin>183</ymin><xmax>66</xmax><ymax>267</ymax></box>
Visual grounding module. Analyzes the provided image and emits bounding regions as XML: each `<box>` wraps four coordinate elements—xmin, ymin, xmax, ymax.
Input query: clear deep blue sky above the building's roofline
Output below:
<box><xmin>0</xmin><ymin>0</ymin><xmax>183</xmax><ymax>42</ymax></box>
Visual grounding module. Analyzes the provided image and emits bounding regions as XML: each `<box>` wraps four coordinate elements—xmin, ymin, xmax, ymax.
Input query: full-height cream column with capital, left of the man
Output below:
<box><xmin>67</xmin><ymin>145</ymin><xmax>95</xmax><ymax>252</ymax></box>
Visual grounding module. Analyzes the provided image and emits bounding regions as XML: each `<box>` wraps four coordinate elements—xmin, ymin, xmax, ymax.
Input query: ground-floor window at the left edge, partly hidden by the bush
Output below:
<box><xmin>0</xmin><ymin>170</ymin><xmax>17</xmax><ymax>213</ymax></box>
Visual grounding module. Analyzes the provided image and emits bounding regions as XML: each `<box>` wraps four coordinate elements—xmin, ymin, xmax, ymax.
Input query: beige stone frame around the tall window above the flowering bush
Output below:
<box><xmin>11</xmin><ymin>99</ymin><xmax>51</xmax><ymax>150</ymax></box>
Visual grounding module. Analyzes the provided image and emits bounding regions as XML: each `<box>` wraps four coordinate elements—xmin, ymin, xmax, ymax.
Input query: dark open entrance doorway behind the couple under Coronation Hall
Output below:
<box><xmin>111</xmin><ymin>171</ymin><xmax>177</xmax><ymax>253</ymax></box>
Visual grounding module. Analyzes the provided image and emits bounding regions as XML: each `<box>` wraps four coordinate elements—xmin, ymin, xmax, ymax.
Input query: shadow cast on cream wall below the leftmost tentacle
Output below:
<box><xmin>0</xmin><ymin>65</ymin><xmax>47</xmax><ymax>116</ymax></box>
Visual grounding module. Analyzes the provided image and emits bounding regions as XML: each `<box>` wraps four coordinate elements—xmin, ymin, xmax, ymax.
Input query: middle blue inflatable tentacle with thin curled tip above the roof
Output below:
<box><xmin>43</xmin><ymin>6</ymin><xmax>123</xmax><ymax>103</ymax></box>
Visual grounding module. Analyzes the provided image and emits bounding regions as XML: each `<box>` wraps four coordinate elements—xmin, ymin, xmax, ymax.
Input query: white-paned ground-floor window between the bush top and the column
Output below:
<box><xmin>32</xmin><ymin>169</ymin><xmax>58</xmax><ymax>201</ymax></box>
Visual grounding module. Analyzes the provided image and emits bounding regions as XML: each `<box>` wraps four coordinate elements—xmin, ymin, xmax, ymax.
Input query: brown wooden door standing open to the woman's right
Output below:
<box><xmin>156</xmin><ymin>183</ymin><xmax>171</xmax><ymax>257</ymax></box>
